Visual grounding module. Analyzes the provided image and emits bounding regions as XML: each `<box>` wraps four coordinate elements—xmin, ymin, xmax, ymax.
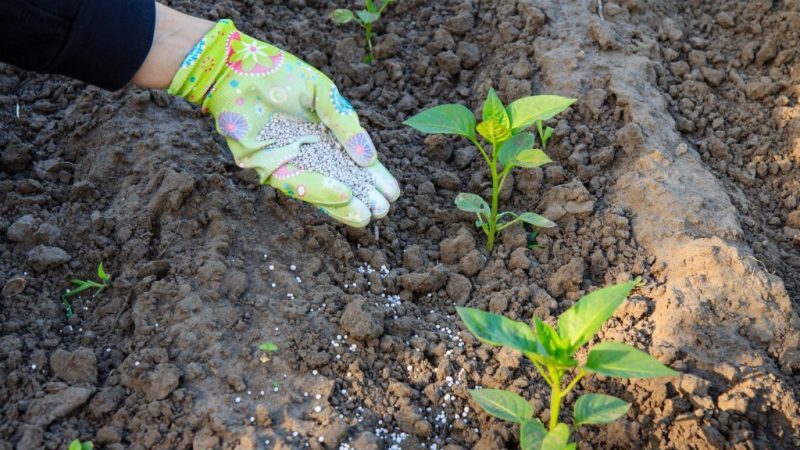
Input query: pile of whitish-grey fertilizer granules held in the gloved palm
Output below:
<box><xmin>258</xmin><ymin>115</ymin><xmax>375</xmax><ymax>206</ymax></box>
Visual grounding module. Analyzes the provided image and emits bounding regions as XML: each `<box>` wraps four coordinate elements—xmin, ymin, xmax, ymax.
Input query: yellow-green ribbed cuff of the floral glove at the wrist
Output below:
<box><xmin>167</xmin><ymin>19</ymin><xmax>237</xmax><ymax>111</ymax></box>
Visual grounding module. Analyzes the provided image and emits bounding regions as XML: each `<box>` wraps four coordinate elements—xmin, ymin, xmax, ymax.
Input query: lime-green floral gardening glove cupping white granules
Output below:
<box><xmin>169</xmin><ymin>20</ymin><xmax>400</xmax><ymax>227</ymax></box>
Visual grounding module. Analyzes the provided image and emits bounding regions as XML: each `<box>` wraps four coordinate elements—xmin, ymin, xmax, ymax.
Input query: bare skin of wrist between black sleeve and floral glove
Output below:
<box><xmin>133</xmin><ymin>3</ymin><xmax>214</xmax><ymax>89</ymax></box>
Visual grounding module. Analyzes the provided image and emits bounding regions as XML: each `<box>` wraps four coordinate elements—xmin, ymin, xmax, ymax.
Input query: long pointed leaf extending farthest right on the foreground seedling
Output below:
<box><xmin>584</xmin><ymin>342</ymin><xmax>678</xmax><ymax>378</ymax></box>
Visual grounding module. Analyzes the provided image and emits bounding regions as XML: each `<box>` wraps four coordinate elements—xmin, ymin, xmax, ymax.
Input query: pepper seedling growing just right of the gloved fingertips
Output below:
<box><xmin>403</xmin><ymin>89</ymin><xmax>575</xmax><ymax>252</ymax></box>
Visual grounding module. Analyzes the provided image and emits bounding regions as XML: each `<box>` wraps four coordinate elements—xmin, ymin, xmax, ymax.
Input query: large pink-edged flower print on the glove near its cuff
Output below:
<box><xmin>227</xmin><ymin>31</ymin><xmax>284</xmax><ymax>76</ymax></box>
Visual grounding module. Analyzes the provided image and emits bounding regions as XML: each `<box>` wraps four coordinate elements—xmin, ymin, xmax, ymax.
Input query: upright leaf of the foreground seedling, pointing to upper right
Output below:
<box><xmin>558</xmin><ymin>278</ymin><xmax>640</xmax><ymax>353</ymax></box>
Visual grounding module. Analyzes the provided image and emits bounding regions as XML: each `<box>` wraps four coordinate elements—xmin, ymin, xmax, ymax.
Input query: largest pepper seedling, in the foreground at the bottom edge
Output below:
<box><xmin>456</xmin><ymin>278</ymin><xmax>678</xmax><ymax>450</ymax></box>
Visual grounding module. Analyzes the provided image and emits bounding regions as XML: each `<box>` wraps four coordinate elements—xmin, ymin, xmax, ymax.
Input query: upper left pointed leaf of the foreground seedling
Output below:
<box><xmin>456</xmin><ymin>307</ymin><xmax>541</xmax><ymax>354</ymax></box>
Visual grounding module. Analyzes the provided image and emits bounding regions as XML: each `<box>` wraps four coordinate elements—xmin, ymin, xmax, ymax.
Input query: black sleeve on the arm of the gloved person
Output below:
<box><xmin>0</xmin><ymin>0</ymin><xmax>155</xmax><ymax>90</ymax></box>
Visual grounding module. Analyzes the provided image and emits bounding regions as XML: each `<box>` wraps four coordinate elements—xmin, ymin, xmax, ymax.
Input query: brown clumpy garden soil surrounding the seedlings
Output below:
<box><xmin>0</xmin><ymin>0</ymin><xmax>800</xmax><ymax>450</ymax></box>
